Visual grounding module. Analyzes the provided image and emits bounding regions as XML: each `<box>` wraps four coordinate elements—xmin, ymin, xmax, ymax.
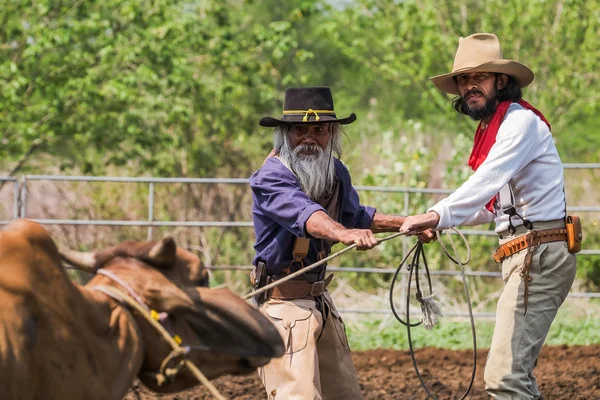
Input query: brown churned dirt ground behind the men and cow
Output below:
<box><xmin>125</xmin><ymin>345</ymin><xmax>600</xmax><ymax>400</ymax></box>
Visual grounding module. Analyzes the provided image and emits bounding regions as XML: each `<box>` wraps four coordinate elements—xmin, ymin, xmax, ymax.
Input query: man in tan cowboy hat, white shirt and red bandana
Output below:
<box><xmin>402</xmin><ymin>33</ymin><xmax>578</xmax><ymax>399</ymax></box>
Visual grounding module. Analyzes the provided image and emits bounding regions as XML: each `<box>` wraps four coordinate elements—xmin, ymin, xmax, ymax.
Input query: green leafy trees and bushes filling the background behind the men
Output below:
<box><xmin>0</xmin><ymin>0</ymin><xmax>600</xmax><ymax>176</ymax></box>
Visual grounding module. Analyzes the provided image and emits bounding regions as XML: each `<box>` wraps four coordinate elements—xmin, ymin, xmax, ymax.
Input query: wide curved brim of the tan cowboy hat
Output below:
<box><xmin>429</xmin><ymin>60</ymin><xmax>534</xmax><ymax>95</ymax></box>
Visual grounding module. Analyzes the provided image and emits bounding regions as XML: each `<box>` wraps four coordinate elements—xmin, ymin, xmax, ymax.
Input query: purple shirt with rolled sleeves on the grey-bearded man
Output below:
<box><xmin>250</xmin><ymin>157</ymin><xmax>375</xmax><ymax>274</ymax></box>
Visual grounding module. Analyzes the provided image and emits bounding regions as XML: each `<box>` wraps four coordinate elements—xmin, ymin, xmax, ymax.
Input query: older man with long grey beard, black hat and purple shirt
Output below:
<box><xmin>250</xmin><ymin>87</ymin><xmax>418</xmax><ymax>400</ymax></box>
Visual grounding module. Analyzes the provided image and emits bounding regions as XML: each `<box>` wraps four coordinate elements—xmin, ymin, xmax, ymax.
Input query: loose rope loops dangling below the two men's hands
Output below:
<box><xmin>390</xmin><ymin>228</ymin><xmax>477</xmax><ymax>400</ymax></box>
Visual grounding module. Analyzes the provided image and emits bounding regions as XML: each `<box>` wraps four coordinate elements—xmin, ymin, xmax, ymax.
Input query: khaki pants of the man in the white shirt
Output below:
<box><xmin>484</xmin><ymin>221</ymin><xmax>576</xmax><ymax>400</ymax></box>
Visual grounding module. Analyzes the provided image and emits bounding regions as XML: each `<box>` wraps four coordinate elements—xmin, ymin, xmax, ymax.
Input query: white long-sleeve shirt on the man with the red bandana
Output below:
<box><xmin>430</xmin><ymin>103</ymin><xmax>565</xmax><ymax>232</ymax></box>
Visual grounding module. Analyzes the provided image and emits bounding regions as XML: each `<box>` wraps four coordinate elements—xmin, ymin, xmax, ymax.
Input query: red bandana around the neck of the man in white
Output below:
<box><xmin>468</xmin><ymin>100</ymin><xmax>551</xmax><ymax>213</ymax></box>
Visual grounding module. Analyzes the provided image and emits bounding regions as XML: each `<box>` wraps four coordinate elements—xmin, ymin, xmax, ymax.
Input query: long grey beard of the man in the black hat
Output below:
<box><xmin>279</xmin><ymin>135</ymin><xmax>335</xmax><ymax>201</ymax></box>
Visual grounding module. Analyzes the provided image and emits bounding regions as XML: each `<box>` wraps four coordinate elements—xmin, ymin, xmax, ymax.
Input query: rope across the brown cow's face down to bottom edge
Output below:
<box><xmin>94</xmin><ymin>285</ymin><xmax>225</xmax><ymax>400</ymax></box>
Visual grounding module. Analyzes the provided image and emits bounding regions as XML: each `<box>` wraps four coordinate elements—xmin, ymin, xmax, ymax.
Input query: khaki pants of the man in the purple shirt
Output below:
<box><xmin>258</xmin><ymin>291</ymin><xmax>363</xmax><ymax>400</ymax></box>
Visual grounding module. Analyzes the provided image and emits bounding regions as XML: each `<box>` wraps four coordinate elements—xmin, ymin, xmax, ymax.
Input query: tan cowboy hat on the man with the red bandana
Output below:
<box><xmin>429</xmin><ymin>33</ymin><xmax>534</xmax><ymax>94</ymax></box>
